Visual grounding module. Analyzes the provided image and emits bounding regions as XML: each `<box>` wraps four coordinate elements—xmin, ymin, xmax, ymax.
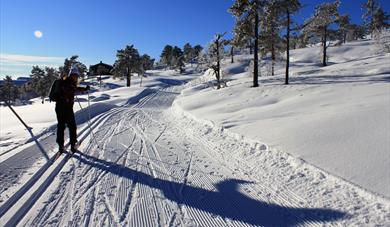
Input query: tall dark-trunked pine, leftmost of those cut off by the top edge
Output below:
<box><xmin>229</xmin><ymin>0</ymin><xmax>266</xmax><ymax>87</ymax></box>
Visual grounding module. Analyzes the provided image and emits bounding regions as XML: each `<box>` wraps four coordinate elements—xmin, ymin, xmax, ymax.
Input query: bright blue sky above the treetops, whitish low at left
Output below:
<box><xmin>0</xmin><ymin>0</ymin><xmax>390</xmax><ymax>78</ymax></box>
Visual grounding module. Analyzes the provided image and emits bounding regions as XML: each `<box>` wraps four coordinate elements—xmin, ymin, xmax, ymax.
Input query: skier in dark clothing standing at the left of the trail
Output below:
<box><xmin>55</xmin><ymin>65</ymin><xmax>89</xmax><ymax>154</ymax></box>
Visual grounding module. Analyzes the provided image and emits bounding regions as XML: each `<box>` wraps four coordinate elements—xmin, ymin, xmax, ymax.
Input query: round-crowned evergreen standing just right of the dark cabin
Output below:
<box><xmin>113</xmin><ymin>45</ymin><xmax>140</xmax><ymax>87</ymax></box>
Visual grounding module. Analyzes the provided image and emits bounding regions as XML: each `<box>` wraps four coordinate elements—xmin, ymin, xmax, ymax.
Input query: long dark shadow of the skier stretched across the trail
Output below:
<box><xmin>73</xmin><ymin>153</ymin><xmax>348</xmax><ymax>226</ymax></box>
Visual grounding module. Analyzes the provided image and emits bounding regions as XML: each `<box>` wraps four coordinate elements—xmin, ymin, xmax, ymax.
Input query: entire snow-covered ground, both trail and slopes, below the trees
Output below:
<box><xmin>0</xmin><ymin>38</ymin><xmax>390</xmax><ymax>226</ymax></box>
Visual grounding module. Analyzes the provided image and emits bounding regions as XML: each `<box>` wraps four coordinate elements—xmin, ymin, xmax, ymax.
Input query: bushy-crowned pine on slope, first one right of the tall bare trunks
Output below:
<box><xmin>304</xmin><ymin>0</ymin><xmax>340</xmax><ymax>66</ymax></box>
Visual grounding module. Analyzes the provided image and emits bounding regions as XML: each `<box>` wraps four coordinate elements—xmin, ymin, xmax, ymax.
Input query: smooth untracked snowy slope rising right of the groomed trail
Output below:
<box><xmin>175</xmin><ymin>40</ymin><xmax>390</xmax><ymax>197</ymax></box>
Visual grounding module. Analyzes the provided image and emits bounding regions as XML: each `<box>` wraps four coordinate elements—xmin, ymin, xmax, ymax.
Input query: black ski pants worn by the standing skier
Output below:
<box><xmin>56</xmin><ymin>103</ymin><xmax>77</xmax><ymax>147</ymax></box>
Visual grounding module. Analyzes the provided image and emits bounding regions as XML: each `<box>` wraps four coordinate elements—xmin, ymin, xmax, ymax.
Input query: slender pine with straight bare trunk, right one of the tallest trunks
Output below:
<box><xmin>280</xmin><ymin>0</ymin><xmax>302</xmax><ymax>84</ymax></box>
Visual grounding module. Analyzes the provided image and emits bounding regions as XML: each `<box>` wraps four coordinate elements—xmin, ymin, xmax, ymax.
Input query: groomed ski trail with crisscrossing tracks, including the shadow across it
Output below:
<box><xmin>0</xmin><ymin>80</ymin><xmax>390</xmax><ymax>226</ymax></box>
